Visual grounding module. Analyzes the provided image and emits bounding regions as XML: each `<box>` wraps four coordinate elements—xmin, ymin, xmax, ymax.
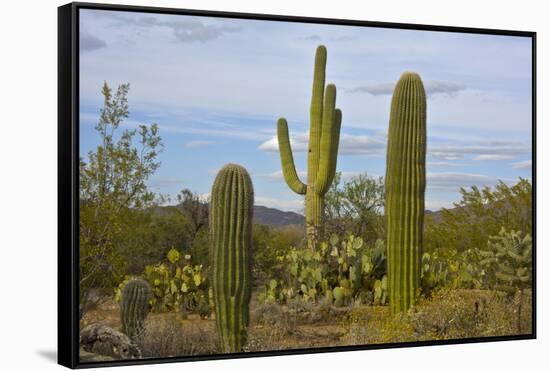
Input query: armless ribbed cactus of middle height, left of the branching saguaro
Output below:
<box><xmin>210</xmin><ymin>164</ymin><xmax>254</xmax><ymax>353</ymax></box>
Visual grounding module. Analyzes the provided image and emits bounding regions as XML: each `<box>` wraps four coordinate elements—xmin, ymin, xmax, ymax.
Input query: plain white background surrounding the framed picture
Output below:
<box><xmin>0</xmin><ymin>0</ymin><xmax>550</xmax><ymax>371</ymax></box>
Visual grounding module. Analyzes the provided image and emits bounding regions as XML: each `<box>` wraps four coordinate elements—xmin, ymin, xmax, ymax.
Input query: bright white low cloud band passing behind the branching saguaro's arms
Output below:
<box><xmin>258</xmin><ymin>133</ymin><xmax>386</xmax><ymax>155</ymax></box>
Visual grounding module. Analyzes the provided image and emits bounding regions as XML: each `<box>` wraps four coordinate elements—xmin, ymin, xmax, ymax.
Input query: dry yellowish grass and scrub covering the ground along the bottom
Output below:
<box><xmin>81</xmin><ymin>290</ymin><xmax>531</xmax><ymax>357</ymax></box>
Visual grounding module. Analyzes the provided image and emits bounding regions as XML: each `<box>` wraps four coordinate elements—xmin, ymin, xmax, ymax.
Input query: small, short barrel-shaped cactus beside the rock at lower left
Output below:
<box><xmin>120</xmin><ymin>279</ymin><xmax>151</xmax><ymax>342</ymax></box>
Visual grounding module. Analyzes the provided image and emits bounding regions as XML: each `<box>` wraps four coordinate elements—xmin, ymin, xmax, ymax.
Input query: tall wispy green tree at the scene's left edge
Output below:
<box><xmin>79</xmin><ymin>82</ymin><xmax>162</xmax><ymax>315</ymax></box>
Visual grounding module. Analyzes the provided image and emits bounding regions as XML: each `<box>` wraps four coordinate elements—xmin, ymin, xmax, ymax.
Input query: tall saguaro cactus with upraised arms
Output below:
<box><xmin>277</xmin><ymin>45</ymin><xmax>342</xmax><ymax>248</ymax></box>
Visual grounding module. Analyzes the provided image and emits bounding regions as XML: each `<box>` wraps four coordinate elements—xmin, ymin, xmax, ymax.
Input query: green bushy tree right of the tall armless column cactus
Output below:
<box><xmin>422</xmin><ymin>179</ymin><xmax>532</xmax><ymax>294</ymax></box>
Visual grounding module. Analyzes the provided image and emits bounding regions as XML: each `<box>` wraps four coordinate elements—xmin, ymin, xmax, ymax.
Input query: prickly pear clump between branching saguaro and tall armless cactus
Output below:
<box><xmin>260</xmin><ymin>235</ymin><xmax>387</xmax><ymax>306</ymax></box>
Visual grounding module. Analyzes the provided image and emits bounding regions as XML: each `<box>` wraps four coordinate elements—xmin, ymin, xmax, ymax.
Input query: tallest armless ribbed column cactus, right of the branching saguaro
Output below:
<box><xmin>385</xmin><ymin>72</ymin><xmax>426</xmax><ymax>314</ymax></box>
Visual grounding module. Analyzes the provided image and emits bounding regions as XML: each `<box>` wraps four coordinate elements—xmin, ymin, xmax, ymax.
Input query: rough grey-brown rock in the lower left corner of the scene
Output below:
<box><xmin>80</xmin><ymin>324</ymin><xmax>141</xmax><ymax>359</ymax></box>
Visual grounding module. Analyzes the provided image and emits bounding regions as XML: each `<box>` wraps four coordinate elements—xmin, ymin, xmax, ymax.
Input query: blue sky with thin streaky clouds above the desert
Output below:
<box><xmin>80</xmin><ymin>10</ymin><xmax>532</xmax><ymax>212</ymax></box>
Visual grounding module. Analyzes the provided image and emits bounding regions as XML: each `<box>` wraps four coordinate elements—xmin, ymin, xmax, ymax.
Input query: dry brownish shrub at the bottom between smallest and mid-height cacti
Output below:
<box><xmin>139</xmin><ymin>314</ymin><xmax>220</xmax><ymax>358</ymax></box>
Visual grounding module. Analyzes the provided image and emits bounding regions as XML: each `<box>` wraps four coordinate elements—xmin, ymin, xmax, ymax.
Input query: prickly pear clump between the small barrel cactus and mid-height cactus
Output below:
<box><xmin>115</xmin><ymin>248</ymin><xmax>211</xmax><ymax>317</ymax></box>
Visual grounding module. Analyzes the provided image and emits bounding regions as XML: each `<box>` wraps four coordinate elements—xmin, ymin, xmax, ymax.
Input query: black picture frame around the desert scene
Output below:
<box><xmin>58</xmin><ymin>2</ymin><xmax>537</xmax><ymax>368</ymax></box>
